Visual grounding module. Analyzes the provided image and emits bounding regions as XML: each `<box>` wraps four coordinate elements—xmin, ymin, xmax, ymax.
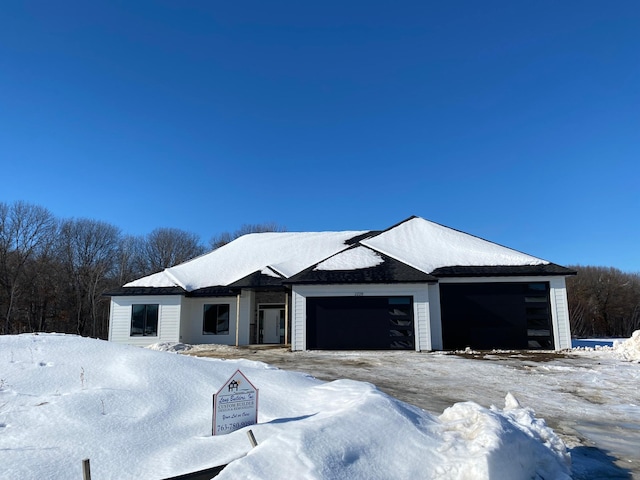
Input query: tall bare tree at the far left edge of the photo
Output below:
<box><xmin>0</xmin><ymin>202</ymin><xmax>56</xmax><ymax>333</ymax></box>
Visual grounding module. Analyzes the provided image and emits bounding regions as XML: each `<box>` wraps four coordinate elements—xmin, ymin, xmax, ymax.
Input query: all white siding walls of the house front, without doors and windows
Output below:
<box><xmin>109</xmin><ymin>276</ymin><xmax>571</xmax><ymax>351</ymax></box>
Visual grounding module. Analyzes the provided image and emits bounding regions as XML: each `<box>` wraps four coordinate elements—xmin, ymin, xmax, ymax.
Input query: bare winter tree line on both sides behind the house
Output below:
<box><xmin>0</xmin><ymin>202</ymin><xmax>640</xmax><ymax>338</ymax></box>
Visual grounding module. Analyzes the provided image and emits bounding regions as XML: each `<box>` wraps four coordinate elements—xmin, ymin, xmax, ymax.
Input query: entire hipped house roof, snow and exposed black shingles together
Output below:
<box><xmin>116</xmin><ymin>216</ymin><xmax>574</xmax><ymax>296</ymax></box>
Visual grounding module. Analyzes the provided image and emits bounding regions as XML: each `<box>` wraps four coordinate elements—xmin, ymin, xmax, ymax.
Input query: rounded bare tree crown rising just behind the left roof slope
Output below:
<box><xmin>141</xmin><ymin>228</ymin><xmax>205</xmax><ymax>273</ymax></box>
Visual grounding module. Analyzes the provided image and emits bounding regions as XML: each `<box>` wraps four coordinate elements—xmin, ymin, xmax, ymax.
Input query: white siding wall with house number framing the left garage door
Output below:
<box><xmin>291</xmin><ymin>284</ymin><xmax>432</xmax><ymax>351</ymax></box>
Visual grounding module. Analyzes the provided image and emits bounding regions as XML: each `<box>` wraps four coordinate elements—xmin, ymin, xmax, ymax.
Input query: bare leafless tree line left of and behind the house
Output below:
<box><xmin>0</xmin><ymin>201</ymin><xmax>284</xmax><ymax>338</ymax></box>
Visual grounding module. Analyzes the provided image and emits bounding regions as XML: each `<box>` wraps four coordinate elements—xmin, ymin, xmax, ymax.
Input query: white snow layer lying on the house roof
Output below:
<box><xmin>125</xmin><ymin>217</ymin><xmax>549</xmax><ymax>291</ymax></box>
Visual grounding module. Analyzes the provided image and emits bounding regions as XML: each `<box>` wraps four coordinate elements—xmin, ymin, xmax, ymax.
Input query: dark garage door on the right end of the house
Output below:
<box><xmin>440</xmin><ymin>282</ymin><xmax>554</xmax><ymax>350</ymax></box>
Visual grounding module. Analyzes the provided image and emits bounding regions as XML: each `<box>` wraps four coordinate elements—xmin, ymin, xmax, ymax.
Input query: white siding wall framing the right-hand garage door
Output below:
<box><xmin>438</xmin><ymin>276</ymin><xmax>571</xmax><ymax>350</ymax></box>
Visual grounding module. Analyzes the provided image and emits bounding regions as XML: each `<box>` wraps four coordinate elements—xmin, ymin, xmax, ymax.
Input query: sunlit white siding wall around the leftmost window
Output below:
<box><xmin>109</xmin><ymin>295</ymin><xmax>184</xmax><ymax>346</ymax></box>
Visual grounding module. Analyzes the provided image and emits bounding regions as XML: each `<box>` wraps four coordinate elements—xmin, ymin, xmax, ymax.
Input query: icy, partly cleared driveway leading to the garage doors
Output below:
<box><xmin>185</xmin><ymin>345</ymin><xmax>640</xmax><ymax>479</ymax></box>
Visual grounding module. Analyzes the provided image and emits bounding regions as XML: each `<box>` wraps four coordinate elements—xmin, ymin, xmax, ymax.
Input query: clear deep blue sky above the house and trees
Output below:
<box><xmin>0</xmin><ymin>0</ymin><xmax>640</xmax><ymax>272</ymax></box>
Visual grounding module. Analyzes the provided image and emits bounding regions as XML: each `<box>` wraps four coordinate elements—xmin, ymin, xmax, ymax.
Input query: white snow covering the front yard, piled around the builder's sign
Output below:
<box><xmin>0</xmin><ymin>334</ymin><xmax>640</xmax><ymax>480</ymax></box>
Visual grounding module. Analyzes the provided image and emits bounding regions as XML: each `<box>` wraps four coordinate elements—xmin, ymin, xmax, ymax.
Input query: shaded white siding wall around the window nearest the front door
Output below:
<box><xmin>181</xmin><ymin>296</ymin><xmax>243</xmax><ymax>345</ymax></box>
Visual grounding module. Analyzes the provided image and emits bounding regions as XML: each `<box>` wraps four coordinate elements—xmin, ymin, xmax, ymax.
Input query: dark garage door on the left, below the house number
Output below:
<box><xmin>307</xmin><ymin>297</ymin><xmax>415</xmax><ymax>350</ymax></box>
